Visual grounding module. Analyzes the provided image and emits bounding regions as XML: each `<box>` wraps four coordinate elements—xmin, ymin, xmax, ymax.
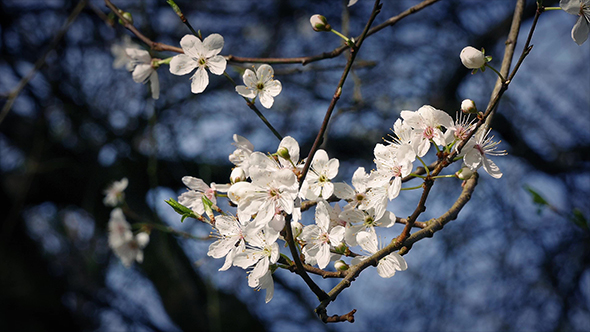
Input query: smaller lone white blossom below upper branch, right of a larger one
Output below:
<box><xmin>236</xmin><ymin>64</ymin><xmax>282</xmax><ymax>108</ymax></box>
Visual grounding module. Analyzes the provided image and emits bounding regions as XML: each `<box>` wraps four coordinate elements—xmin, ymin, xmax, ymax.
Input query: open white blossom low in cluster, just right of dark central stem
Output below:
<box><xmin>301</xmin><ymin>200</ymin><xmax>345</xmax><ymax>269</ymax></box>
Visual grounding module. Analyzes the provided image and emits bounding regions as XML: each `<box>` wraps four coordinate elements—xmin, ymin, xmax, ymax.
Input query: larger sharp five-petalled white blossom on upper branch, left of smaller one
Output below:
<box><xmin>170</xmin><ymin>33</ymin><xmax>227</xmax><ymax>94</ymax></box>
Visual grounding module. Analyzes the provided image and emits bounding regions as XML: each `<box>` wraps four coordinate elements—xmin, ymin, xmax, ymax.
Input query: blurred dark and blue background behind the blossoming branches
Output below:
<box><xmin>0</xmin><ymin>0</ymin><xmax>590</xmax><ymax>331</ymax></box>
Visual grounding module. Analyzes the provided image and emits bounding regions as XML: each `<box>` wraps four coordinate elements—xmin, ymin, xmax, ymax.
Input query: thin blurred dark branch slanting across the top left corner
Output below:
<box><xmin>0</xmin><ymin>0</ymin><xmax>88</xmax><ymax>124</ymax></box>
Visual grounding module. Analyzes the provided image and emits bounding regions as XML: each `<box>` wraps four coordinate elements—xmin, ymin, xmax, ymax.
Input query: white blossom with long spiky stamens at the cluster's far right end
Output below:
<box><xmin>460</xmin><ymin>130</ymin><xmax>506</xmax><ymax>179</ymax></box>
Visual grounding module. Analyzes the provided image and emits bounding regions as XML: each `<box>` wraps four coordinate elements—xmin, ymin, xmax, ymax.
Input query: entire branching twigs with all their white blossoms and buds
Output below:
<box><xmin>99</xmin><ymin>0</ymin><xmax>590</xmax><ymax>322</ymax></box>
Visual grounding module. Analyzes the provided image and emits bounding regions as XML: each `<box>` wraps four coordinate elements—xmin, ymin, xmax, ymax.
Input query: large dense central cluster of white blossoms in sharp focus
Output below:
<box><xmin>172</xmin><ymin>102</ymin><xmax>504</xmax><ymax>302</ymax></box>
